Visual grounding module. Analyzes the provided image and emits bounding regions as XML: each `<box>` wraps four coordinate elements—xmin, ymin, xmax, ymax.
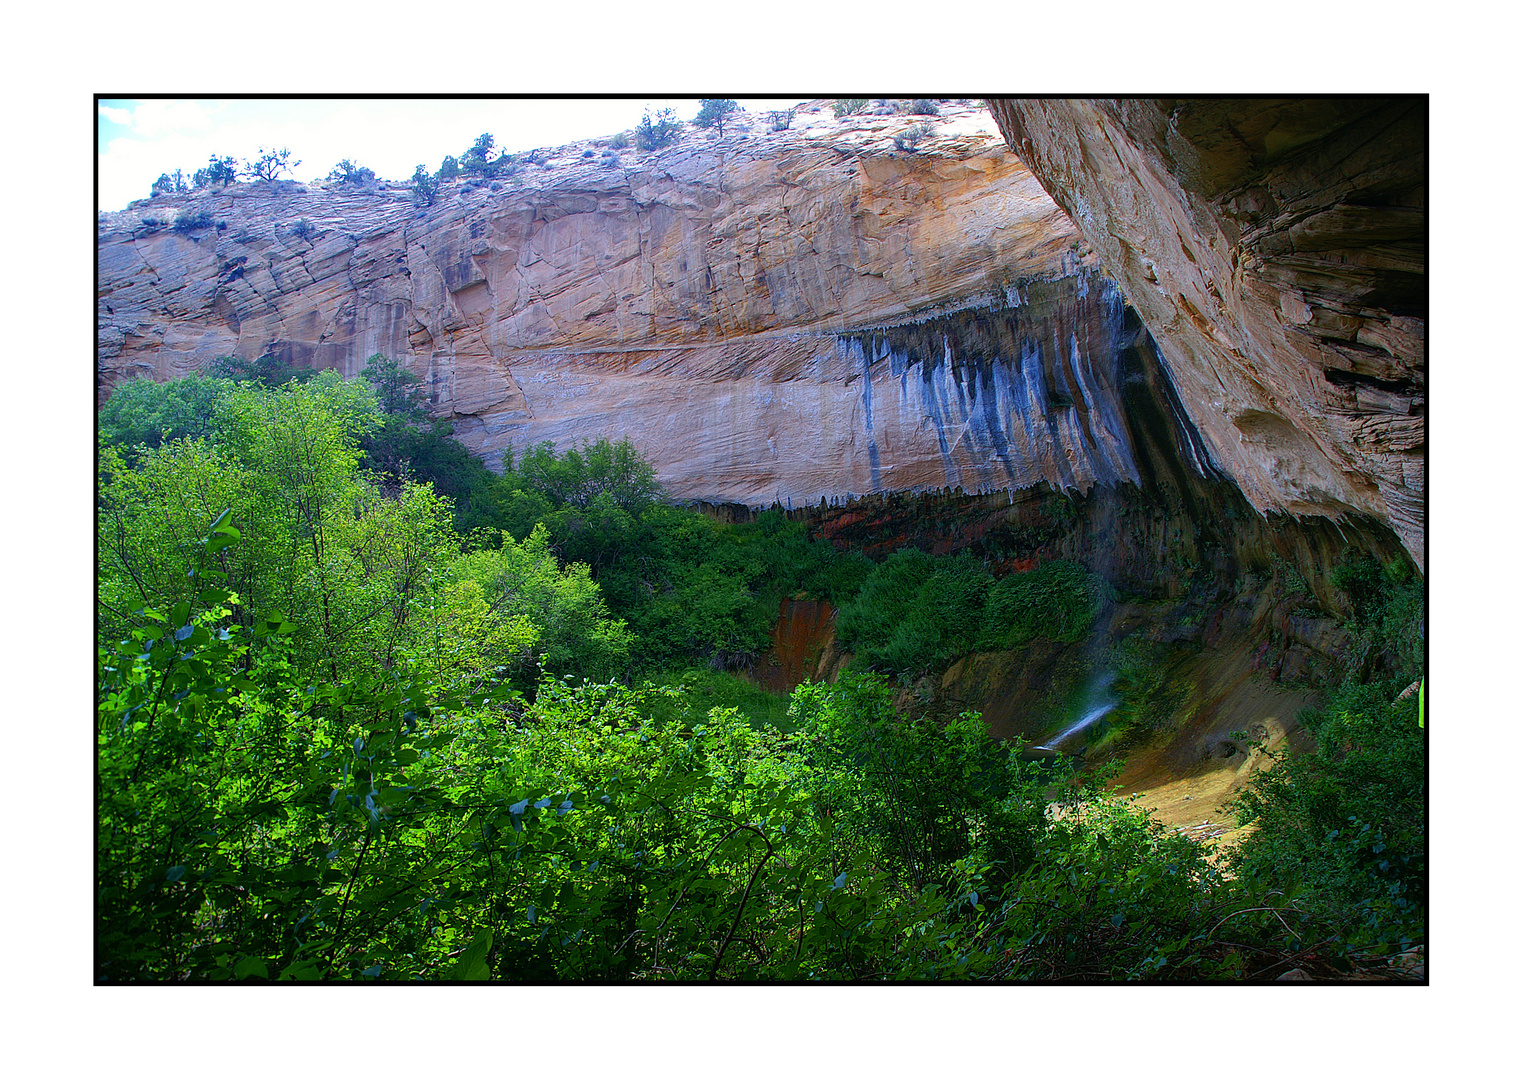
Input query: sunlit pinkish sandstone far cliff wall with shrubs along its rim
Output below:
<box><xmin>99</xmin><ymin>104</ymin><xmax>1163</xmax><ymax>506</ymax></box>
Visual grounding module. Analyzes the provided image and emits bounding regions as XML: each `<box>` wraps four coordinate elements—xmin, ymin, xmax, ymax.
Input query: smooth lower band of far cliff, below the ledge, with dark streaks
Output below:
<box><xmin>487</xmin><ymin>276</ymin><xmax>1163</xmax><ymax>509</ymax></box>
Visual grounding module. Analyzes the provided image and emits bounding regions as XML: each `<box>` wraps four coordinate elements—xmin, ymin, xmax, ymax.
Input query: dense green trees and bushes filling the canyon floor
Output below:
<box><xmin>96</xmin><ymin>356</ymin><xmax>1424</xmax><ymax>983</ymax></box>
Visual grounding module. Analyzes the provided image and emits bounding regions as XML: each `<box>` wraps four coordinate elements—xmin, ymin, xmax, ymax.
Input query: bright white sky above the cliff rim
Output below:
<box><xmin>96</xmin><ymin>97</ymin><xmax>803</xmax><ymax>210</ymax></box>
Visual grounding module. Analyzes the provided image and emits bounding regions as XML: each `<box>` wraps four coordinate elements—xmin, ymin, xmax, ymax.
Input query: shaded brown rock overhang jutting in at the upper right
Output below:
<box><xmin>990</xmin><ymin>97</ymin><xmax>1427</xmax><ymax>567</ymax></box>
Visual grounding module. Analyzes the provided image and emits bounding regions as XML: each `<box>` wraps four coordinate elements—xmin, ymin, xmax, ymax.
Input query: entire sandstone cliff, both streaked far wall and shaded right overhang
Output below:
<box><xmin>97</xmin><ymin>101</ymin><xmax>1424</xmax><ymax>564</ymax></box>
